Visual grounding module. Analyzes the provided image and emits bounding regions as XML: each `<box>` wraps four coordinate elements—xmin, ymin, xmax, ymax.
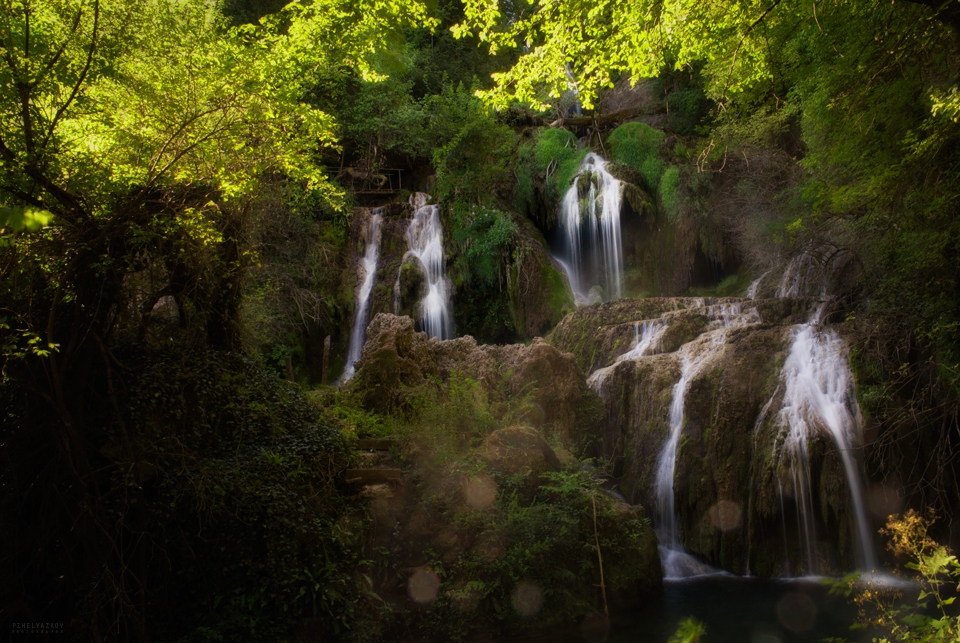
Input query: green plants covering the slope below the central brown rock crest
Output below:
<box><xmin>328</xmin><ymin>372</ymin><xmax>656</xmax><ymax>640</ymax></box>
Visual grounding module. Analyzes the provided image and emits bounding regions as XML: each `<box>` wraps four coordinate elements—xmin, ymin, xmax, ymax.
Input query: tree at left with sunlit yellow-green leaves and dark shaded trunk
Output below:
<box><xmin>0</xmin><ymin>0</ymin><xmax>429</xmax><ymax>640</ymax></box>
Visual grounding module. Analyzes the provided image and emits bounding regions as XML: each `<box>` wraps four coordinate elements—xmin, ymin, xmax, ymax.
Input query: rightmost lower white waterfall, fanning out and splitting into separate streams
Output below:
<box><xmin>777</xmin><ymin>305</ymin><xmax>877</xmax><ymax>573</ymax></box>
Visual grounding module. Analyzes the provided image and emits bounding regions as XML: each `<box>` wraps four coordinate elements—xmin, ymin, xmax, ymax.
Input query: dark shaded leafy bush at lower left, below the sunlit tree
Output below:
<box><xmin>118</xmin><ymin>351</ymin><xmax>366</xmax><ymax>641</ymax></box>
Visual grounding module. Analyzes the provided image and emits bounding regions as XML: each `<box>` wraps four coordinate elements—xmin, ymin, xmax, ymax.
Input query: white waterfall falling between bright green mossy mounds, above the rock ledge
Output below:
<box><xmin>557</xmin><ymin>153</ymin><xmax>623</xmax><ymax>304</ymax></box>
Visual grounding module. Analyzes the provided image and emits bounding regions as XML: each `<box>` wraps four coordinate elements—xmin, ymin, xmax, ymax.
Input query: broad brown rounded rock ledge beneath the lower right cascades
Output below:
<box><xmin>550</xmin><ymin>298</ymin><xmax>872</xmax><ymax>576</ymax></box>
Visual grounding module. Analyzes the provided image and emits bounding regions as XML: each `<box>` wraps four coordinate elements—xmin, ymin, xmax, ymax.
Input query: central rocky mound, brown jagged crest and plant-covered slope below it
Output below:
<box><xmin>343</xmin><ymin>313</ymin><xmax>663</xmax><ymax>633</ymax></box>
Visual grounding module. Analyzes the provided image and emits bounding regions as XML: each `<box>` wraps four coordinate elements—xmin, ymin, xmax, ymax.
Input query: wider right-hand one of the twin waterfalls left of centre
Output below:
<box><xmin>407</xmin><ymin>192</ymin><xmax>453</xmax><ymax>339</ymax></box>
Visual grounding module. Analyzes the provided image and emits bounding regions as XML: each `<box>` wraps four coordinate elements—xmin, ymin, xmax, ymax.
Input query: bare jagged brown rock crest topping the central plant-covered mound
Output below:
<box><xmin>350</xmin><ymin>313</ymin><xmax>596</xmax><ymax>439</ymax></box>
